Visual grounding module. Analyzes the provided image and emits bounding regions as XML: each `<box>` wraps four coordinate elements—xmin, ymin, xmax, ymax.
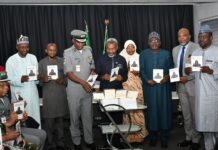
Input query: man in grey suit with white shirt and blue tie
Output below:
<box><xmin>173</xmin><ymin>28</ymin><xmax>201</xmax><ymax>150</ymax></box>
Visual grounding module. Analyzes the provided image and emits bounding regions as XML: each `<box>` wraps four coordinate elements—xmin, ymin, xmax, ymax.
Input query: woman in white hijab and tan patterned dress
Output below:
<box><xmin>120</xmin><ymin>40</ymin><xmax>148</xmax><ymax>143</ymax></box>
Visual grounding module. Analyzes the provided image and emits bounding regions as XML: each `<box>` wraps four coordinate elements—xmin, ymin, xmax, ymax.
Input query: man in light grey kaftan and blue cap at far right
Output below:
<box><xmin>186</xmin><ymin>25</ymin><xmax>218</xmax><ymax>150</ymax></box>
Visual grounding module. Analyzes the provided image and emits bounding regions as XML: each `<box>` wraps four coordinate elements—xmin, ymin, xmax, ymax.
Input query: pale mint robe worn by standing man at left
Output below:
<box><xmin>6</xmin><ymin>53</ymin><xmax>41</xmax><ymax>123</ymax></box>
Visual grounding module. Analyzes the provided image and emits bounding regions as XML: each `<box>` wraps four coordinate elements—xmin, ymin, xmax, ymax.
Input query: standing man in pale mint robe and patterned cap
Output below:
<box><xmin>6</xmin><ymin>35</ymin><xmax>41</xmax><ymax>124</ymax></box>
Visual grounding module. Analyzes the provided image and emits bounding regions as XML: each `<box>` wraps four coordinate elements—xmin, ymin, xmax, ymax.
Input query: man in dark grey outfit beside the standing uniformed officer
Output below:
<box><xmin>39</xmin><ymin>43</ymin><xmax>68</xmax><ymax>150</ymax></box>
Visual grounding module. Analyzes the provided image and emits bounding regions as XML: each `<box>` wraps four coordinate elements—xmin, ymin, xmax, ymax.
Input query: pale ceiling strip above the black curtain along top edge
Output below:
<box><xmin>0</xmin><ymin>0</ymin><xmax>218</xmax><ymax>5</ymax></box>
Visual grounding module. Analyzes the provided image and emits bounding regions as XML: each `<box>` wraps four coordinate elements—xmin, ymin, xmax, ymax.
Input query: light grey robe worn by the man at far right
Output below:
<box><xmin>192</xmin><ymin>46</ymin><xmax>218</xmax><ymax>132</ymax></box>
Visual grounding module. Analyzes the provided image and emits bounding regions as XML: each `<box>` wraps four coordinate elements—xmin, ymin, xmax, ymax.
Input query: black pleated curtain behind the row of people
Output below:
<box><xmin>0</xmin><ymin>5</ymin><xmax>193</xmax><ymax>65</ymax></box>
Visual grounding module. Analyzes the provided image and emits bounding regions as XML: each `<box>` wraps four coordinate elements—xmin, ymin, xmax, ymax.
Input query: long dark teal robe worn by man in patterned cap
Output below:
<box><xmin>140</xmin><ymin>49</ymin><xmax>172</xmax><ymax>131</ymax></box>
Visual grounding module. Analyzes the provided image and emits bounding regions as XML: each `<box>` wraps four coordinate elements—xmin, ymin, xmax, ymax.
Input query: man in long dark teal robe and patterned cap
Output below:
<box><xmin>139</xmin><ymin>32</ymin><xmax>172</xmax><ymax>148</ymax></box>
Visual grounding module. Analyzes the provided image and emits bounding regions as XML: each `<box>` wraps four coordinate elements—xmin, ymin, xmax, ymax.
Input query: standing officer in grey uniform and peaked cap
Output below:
<box><xmin>64</xmin><ymin>30</ymin><xmax>97</xmax><ymax>150</ymax></box>
